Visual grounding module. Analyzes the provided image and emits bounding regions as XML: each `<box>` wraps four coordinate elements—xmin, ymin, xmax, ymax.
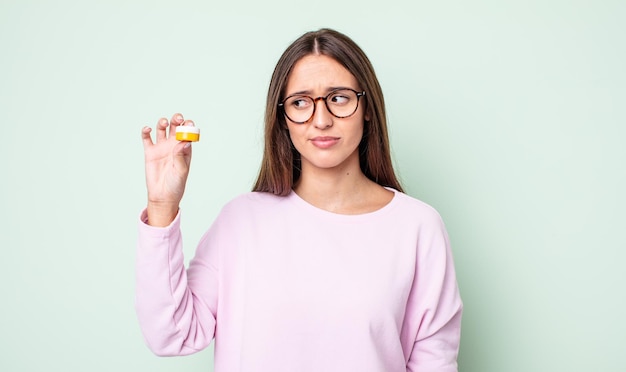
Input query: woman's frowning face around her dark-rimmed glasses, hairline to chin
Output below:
<box><xmin>285</xmin><ymin>55</ymin><xmax>365</xmax><ymax>173</ymax></box>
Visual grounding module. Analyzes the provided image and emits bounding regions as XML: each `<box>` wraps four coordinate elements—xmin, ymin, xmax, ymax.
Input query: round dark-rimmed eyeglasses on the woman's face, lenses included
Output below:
<box><xmin>278</xmin><ymin>88</ymin><xmax>365</xmax><ymax>124</ymax></box>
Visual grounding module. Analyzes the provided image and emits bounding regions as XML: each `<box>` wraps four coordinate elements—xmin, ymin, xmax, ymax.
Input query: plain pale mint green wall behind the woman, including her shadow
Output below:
<box><xmin>0</xmin><ymin>0</ymin><xmax>626</xmax><ymax>372</ymax></box>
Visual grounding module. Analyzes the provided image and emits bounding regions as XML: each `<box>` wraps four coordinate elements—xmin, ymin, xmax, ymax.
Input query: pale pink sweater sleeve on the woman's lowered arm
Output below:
<box><xmin>405</xmin><ymin>214</ymin><xmax>463</xmax><ymax>372</ymax></box>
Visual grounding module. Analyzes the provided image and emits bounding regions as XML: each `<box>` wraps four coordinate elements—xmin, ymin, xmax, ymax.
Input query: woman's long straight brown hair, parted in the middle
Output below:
<box><xmin>252</xmin><ymin>28</ymin><xmax>402</xmax><ymax>196</ymax></box>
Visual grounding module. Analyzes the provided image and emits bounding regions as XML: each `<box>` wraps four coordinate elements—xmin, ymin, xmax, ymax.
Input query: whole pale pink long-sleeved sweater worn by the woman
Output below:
<box><xmin>136</xmin><ymin>192</ymin><xmax>462</xmax><ymax>372</ymax></box>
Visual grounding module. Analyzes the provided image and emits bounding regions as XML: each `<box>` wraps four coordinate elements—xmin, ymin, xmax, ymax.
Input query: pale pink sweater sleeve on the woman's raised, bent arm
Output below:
<box><xmin>135</xmin><ymin>210</ymin><xmax>217</xmax><ymax>356</ymax></box>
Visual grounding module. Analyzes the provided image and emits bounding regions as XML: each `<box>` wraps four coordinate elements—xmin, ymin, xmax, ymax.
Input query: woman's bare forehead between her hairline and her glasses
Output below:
<box><xmin>285</xmin><ymin>54</ymin><xmax>359</xmax><ymax>95</ymax></box>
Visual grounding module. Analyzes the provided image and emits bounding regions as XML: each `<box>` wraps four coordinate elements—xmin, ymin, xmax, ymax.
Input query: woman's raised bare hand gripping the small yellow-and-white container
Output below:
<box><xmin>141</xmin><ymin>114</ymin><xmax>194</xmax><ymax>226</ymax></box>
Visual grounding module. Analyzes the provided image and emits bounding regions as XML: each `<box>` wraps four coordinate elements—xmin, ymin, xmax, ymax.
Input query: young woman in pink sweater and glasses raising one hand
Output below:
<box><xmin>136</xmin><ymin>29</ymin><xmax>462</xmax><ymax>372</ymax></box>
